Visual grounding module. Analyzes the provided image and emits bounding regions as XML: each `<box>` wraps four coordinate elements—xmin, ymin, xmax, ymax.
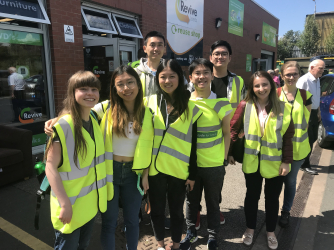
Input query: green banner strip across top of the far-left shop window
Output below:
<box><xmin>0</xmin><ymin>29</ymin><xmax>43</xmax><ymax>46</ymax></box>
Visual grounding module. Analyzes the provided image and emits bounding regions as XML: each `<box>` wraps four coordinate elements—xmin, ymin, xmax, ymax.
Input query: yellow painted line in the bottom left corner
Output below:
<box><xmin>0</xmin><ymin>217</ymin><xmax>53</xmax><ymax>250</ymax></box>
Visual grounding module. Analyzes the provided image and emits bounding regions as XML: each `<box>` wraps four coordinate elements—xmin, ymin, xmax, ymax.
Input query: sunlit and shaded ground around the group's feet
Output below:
<box><xmin>0</xmin><ymin>145</ymin><xmax>334</xmax><ymax>250</ymax></box>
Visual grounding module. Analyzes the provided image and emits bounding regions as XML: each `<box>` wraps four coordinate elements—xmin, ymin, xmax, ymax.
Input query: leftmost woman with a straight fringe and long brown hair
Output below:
<box><xmin>45</xmin><ymin>71</ymin><xmax>107</xmax><ymax>250</ymax></box>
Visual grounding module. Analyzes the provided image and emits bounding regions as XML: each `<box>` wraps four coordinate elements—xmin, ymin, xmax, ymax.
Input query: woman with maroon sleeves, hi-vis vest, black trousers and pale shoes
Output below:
<box><xmin>229</xmin><ymin>71</ymin><xmax>294</xmax><ymax>249</ymax></box>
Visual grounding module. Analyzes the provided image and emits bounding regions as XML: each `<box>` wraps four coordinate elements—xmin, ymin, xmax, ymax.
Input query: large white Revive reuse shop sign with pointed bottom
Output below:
<box><xmin>166</xmin><ymin>0</ymin><xmax>204</xmax><ymax>66</ymax></box>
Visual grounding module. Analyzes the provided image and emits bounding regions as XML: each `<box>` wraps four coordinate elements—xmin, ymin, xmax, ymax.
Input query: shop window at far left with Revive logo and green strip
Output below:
<box><xmin>0</xmin><ymin>29</ymin><xmax>49</xmax><ymax>128</ymax></box>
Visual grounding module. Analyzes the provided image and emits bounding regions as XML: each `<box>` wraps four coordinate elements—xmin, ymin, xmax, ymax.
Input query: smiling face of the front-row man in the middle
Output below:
<box><xmin>189</xmin><ymin>65</ymin><xmax>213</xmax><ymax>90</ymax></box>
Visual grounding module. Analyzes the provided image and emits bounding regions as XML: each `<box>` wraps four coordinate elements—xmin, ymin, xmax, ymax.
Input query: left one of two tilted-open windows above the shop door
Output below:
<box><xmin>81</xmin><ymin>6</ymin><xmax>117</xmax><ymax>34</ymax></box>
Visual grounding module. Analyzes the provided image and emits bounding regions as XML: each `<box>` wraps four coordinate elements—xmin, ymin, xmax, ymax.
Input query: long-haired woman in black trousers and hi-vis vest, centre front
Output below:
<box><xmin>146</xmin><ymin>59</ymin><xmax>202</xmax><ymax>250</ymax></box>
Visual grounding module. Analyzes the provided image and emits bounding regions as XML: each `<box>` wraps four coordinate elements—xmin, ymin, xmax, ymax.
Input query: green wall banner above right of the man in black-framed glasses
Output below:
<box><xmin>228</xmin><ymin>0</ymin><xmax>244</xmax><ymax>36</ymax></box>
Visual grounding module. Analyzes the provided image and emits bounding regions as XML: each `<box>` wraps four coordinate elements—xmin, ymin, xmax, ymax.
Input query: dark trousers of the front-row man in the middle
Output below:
<box><xmin>186</xmin><ymin>166</ymin><xmax>225</xmax><ymax>239</ymax></box>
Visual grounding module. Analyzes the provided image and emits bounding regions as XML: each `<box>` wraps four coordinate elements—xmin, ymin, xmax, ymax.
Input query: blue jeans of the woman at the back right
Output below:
<box><xmin>282</xmin><ymin>159</ymin><xmax>305</xmax><ymax>212</ymax></box>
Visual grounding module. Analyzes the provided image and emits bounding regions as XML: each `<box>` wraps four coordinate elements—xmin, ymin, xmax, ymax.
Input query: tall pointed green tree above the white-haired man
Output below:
<box><xmin>298</xmin><ymin>15</ymin><xmax>321</xmax><ymax>56</ymax></box>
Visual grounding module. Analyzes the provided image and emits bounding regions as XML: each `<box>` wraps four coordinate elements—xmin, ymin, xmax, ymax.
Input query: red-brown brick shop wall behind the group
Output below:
<box><xmin>47</xmin><ymin>0</ymin><xmax>279</xmax><ymax>112</ymax></box>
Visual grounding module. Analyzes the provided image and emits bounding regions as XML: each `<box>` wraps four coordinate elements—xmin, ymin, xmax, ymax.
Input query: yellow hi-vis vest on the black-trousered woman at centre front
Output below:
<box><xmin>145</xmin><ymin>95</ymin><xmax>202</xmax><ymax>180</ymax></box>
